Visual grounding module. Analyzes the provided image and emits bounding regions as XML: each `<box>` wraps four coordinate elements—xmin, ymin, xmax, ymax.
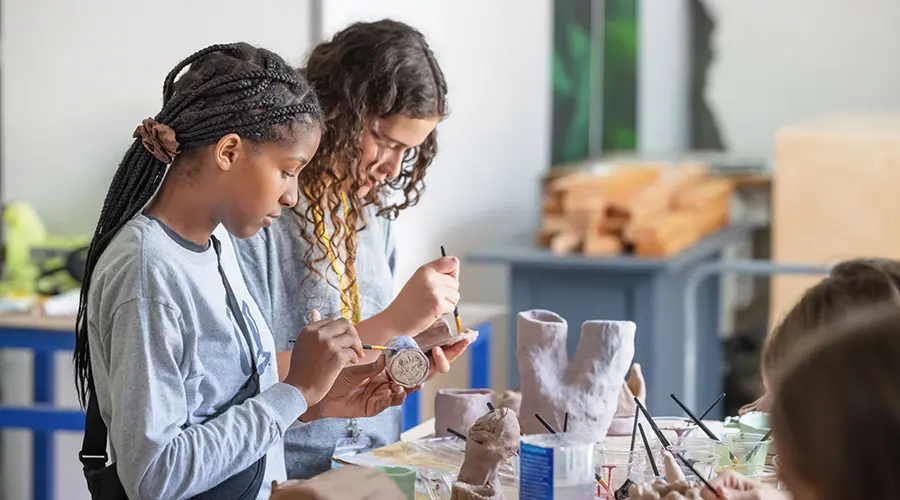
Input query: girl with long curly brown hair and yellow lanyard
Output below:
<box><xmin>229</xmin><ymin>20</ymin><xmax>471</xmax><ymax>479</ymax></box>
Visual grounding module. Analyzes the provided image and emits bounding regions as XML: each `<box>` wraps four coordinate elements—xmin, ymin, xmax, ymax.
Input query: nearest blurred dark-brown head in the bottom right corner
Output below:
<box><xmin>772</xmin><ymin>302</ymin><xmax>900</xmax><ymax>500</ymax></box>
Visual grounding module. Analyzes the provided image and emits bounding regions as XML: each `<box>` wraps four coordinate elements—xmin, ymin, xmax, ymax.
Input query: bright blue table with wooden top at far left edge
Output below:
<box><xmin>0</xmin><ymin>315</ymin><xmax>84</xmax><ymax>500</ymax></box>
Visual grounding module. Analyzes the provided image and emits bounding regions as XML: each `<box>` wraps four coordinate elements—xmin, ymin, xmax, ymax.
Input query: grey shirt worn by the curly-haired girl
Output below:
<box><xmin>233</xmin><ymin>202</ymin><xmax>402</xmax><ymax>479</ymax></box>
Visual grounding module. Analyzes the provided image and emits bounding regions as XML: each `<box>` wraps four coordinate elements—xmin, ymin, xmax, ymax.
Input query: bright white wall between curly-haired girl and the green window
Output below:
<box><xmin>322</xmin><ymin>0</ymin><xmax>553</xmax><ymax>347</ymax></box>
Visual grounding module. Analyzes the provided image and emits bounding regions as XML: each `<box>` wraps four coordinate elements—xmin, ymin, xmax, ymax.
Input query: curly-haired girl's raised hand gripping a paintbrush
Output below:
<box><xmin>384</xmin><ymin>257</ymin><xmax>459</xmax><ymax>335</ymax></box>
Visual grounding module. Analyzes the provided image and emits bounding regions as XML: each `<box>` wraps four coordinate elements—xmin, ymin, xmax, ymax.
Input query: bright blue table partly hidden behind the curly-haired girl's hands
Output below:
<box><xmin>403</xmin><ymin>304</ymin><xmax>505</xmax><ymax>432</ymax></box>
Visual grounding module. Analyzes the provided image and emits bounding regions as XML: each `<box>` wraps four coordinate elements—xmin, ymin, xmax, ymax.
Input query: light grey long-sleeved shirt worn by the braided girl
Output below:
<box><xmin>88</xmin><ymin>215</ymin><xmax>306</xmax><ymax>499</ymax></box>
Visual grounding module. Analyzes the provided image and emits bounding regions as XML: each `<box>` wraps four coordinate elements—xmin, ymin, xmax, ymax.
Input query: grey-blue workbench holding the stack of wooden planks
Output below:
<box><xmin>467</xmin><ymin>226</ymin><xmax>751</xmax><ymax>419</ymax></box>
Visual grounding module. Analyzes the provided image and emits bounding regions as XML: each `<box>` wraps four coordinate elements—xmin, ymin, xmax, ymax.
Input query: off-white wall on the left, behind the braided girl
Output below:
<box><xmin>0</xmin><ymin>0</ymin><xmax>311</xmax><ymax>500</ymax></box>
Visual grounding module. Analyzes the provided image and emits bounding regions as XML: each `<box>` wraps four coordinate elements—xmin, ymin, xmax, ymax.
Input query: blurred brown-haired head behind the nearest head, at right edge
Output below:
<box><xmin>741</xmin><ymin>259</ymin><xmax>900</xmax><ymax>413</ymax></box>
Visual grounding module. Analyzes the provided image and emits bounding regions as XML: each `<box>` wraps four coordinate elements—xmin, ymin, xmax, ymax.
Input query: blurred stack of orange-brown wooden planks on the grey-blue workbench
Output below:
<box><xmin>538</xmin><ymin>162</ymin><xmax>734</xmax><ymax>257</ymax></box>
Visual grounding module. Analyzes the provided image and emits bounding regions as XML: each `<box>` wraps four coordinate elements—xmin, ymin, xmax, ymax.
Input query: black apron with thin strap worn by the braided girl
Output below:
<box><xmin>78</xmin><ymin>236</ymin><xmax>266</xmax><ymax>500</ymax></box>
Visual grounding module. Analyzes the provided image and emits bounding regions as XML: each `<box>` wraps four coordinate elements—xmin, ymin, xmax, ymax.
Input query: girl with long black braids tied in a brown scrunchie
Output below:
<box><xmin>75</xmin><ymin>43</ymin><xmax>408</xmax><ymax>499</ymax></box>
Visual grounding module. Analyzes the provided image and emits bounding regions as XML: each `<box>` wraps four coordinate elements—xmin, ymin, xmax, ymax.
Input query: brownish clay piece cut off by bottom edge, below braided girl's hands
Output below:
<box><xmin>269</xmin><ymin>465</ymin><xmax>406</xmax><ymax>500</ymax></box>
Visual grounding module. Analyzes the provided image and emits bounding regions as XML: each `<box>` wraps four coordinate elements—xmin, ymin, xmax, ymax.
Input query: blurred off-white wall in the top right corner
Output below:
<box><xmin>704</xmin><ymin>0</ymin><xmax>900</xmax><ymax>155</ymax></box>
